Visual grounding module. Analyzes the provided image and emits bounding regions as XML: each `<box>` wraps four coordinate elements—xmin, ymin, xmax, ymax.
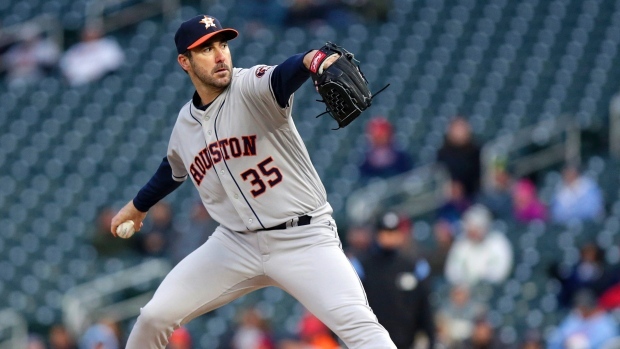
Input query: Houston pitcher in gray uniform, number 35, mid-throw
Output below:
<box><xmin>112</xmin><ymin>15</ymin><xmax>396</xmax><ymax>349</ymax></box>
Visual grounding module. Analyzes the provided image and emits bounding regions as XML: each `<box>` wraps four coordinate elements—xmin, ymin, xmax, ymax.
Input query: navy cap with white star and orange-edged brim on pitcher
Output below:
<box><xmin>174</xmin><ymin>15</ymin><xmax>239</xmax><ymax>54</ymax></box>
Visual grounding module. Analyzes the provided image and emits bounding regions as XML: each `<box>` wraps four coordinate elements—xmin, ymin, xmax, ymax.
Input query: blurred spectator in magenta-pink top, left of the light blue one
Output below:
<box><xmin>512</xmin><ymin>179</ymin><xmax>547</xmax><ymax>223</ymax></box>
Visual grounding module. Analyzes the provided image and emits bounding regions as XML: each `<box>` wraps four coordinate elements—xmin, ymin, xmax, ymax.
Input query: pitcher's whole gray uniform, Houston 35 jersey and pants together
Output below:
<box><xmin>127</xmin><ymin>66</ymin><xmax>396</xmax><ymax>349</ymax></box>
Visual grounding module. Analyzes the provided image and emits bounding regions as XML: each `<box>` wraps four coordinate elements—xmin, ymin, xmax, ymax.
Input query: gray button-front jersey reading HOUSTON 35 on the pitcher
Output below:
<box><xmin>168</xmin><ymin>66</ymin><xmax>332</xmax><ymax>231</ymax></box>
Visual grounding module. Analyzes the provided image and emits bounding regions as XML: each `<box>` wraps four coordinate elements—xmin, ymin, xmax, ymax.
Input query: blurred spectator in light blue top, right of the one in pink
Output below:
<box><xmin>551</xmin><ymin>164</ymin><xmax>603</xmax><ymax>223</ymax></box>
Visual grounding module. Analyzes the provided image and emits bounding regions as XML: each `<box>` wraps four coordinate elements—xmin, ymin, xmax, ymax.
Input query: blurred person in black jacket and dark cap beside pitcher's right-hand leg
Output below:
<box><xmin>356</xmin><ymin>212</ymin><xmax>435</xmax><ymax>349</ymax></box>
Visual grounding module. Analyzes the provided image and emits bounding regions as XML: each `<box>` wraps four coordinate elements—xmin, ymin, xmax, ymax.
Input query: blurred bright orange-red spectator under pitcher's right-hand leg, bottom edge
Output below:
<box><xmin>278</xmin><ymin>312</ymin><xmax>340</xmax><ymax>349</ymax></box>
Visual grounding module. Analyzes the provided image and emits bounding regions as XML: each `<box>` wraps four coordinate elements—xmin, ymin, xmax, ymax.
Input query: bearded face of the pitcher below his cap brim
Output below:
<box><xmin>188</xmin><ymin>39</ymin><xmax>232</xmax><ymax>89</ymax></box>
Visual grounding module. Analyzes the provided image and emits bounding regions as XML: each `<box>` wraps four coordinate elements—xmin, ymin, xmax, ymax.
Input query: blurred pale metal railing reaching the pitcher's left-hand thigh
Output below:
<box><xmin>62</xmin><ymin>259</ymin><xmax>172</xmax><ymax>335</ymax></box>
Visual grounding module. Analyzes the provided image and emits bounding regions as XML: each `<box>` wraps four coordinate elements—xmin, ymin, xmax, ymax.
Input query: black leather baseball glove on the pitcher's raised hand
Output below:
<box><xmin>310</xmin><ymin>42</ymin><xmax>387</xmax><ymax>128</ymax></box>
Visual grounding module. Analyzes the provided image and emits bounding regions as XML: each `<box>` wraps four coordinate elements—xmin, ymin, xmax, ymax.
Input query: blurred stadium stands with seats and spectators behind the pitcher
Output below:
<box><xmin>0</xmin><ymin>0</ymin><xmax>620</xmax><ymax>349</ymax></box>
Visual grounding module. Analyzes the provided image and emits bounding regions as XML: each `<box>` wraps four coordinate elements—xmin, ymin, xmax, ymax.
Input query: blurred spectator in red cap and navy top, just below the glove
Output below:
<box><xmin>359</xmin><ymin>117</ymin><xmax>413</xmax><ymax>181</ymax></box>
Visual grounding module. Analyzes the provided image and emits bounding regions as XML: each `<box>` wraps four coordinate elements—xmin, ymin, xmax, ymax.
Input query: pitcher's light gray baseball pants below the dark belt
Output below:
<box><xmin>127</xmin><ymin>216</ymin><xmax>396</xmax><ymax>349</ymax></box>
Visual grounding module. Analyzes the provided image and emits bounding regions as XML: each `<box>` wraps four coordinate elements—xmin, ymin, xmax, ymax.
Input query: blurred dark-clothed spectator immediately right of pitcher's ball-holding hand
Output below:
<box><xmin>136</xmin><ymin>201</ymin><xmax>179</xmax><ymax>258</ymax></box>
